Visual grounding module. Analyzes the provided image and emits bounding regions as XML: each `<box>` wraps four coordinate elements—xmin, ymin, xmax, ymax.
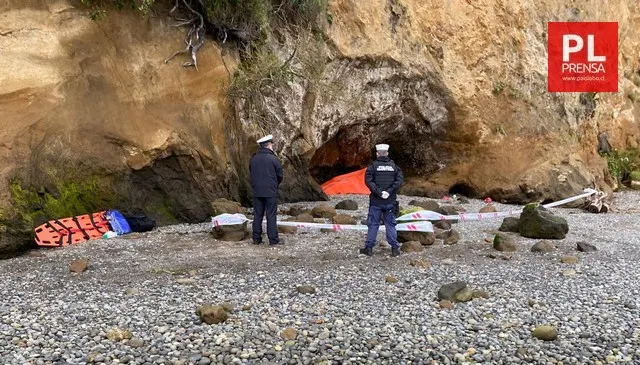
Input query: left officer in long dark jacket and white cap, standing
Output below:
<box><xmin>249</xmin><ymin>135</ymin><xmax>284</xmax><ymax>245</ymax></box>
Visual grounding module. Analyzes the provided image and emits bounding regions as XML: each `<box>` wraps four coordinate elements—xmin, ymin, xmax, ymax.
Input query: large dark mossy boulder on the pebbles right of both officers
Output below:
<box><xmin>518</xmin><ymin>204</ymin><xmax>569</xmax><ymax>239</ymax></box>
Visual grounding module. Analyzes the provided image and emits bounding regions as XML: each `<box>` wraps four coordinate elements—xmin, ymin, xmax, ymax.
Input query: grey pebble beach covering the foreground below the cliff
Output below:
<box><xmin>0</xmin><ymin>192</ymin><xmax>640</xmax><ymax>365</ymax></box>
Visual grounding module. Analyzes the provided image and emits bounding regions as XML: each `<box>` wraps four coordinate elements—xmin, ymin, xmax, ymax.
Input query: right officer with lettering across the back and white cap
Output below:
<box><xmin>360</xmin><ymin>144</ymin><xmax>404</xmax><ymax>257</ymax></box>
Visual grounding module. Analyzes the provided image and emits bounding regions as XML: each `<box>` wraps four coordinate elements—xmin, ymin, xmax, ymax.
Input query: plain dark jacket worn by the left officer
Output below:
<box><xmin>249</xmin><ymin>148</ymin><xmax>284</xmax><ymax>198</ymax></box>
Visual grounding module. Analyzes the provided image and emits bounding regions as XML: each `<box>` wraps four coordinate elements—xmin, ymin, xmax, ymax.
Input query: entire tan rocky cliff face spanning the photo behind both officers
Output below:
<box><xmin>0</xmin><ymin>0</ymin><xmax>640</xmax><ymax>235</ymax></box>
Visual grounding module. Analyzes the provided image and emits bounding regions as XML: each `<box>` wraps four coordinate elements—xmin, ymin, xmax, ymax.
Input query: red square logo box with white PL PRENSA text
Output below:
<box><xmin>547</xmin><ymin>22</ymin><xmax>618</xmax><ymax>92</ymax></box>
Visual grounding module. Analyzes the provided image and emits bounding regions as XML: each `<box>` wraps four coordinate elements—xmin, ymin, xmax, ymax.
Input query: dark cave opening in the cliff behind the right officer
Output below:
<box><xmin>309</xmin><ymin>120</ymin><xmax>437</xmax><ymax>184</ymax></box>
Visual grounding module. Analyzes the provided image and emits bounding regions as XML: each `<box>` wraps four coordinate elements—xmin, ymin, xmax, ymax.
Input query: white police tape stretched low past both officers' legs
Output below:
<box><xmin>211</xmin><ymin>213</ymin><xmax>433</xmax><ymax>232</ymax></box>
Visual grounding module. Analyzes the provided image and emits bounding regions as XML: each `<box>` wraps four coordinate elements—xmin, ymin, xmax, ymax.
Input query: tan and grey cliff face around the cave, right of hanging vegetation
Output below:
<box><xmin>255</xmin><ymin>0</ymin><xmax>640</xmax><ymax>202</ymax></box>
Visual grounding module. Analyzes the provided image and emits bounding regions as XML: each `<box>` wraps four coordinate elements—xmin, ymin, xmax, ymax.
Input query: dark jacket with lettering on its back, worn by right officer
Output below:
<box><xmin>364</xmin><ymin>156</ymin><xmax>404</xmax><ymax>205</ymax></box>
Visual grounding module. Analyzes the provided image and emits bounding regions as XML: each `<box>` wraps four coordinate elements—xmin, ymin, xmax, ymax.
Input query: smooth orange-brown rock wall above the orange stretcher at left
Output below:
<box><xmin>0</xmin><ymin>0</ymin><xmax>246</xmax><ymax>221</ymax></box>
